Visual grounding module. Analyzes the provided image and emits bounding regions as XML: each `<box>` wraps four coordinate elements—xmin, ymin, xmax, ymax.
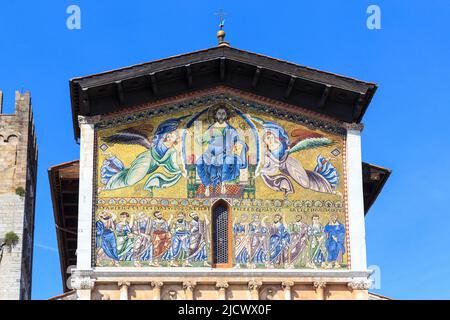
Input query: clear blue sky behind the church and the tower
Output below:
<box><xmin>0</xmin><ymin>0</ymin><xmax>450</xmax><ymax>299</ymax></box>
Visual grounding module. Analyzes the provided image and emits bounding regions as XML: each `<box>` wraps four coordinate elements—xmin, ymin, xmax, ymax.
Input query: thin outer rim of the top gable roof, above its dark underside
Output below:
<box><xmin>70</xmin><ymin>47</ymin><xmax>377</xmax><ymax>139</ymax></box>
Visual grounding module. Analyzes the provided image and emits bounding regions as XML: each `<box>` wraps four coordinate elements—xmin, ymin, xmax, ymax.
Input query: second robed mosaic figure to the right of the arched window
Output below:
<box><xmin>248</xmin><ymin>214</ymin><xmax>268</xmax><ymax>268</ymax></box>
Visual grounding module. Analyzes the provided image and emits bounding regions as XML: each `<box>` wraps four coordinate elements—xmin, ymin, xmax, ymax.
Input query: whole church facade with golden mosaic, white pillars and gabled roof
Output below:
<box><xmin>49</xmin><ymin>37</ymin><xmax>389</xmax><ymax>300</ymax></box>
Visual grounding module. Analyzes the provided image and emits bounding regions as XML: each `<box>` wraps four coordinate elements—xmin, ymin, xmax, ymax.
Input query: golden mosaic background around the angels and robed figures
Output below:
<box><xmin>96</xmin><ymin>99</ymin><xmax>348</xmax><ymax>268</ymax></box>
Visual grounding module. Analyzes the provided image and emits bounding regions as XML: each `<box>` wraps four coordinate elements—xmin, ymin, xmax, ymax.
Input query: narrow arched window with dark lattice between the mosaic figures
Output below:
<box><xmin>212</xmin><ymin>200</ymin><xmax>231</xmax><ymax>268</ymax></box>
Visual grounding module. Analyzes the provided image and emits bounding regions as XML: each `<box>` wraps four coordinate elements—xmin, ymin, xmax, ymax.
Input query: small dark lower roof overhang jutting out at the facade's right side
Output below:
<box><xmin>362</xmin><ymin>162</ymin><xmax>392</xmax><ymax>214</ymax></box>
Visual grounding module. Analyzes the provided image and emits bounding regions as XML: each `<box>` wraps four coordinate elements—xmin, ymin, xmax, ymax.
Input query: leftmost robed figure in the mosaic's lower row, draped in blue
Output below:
<box><xmin>95</xmin><ymin>211</ymin><xmax>119</xmax><ymax>266</ymax></box>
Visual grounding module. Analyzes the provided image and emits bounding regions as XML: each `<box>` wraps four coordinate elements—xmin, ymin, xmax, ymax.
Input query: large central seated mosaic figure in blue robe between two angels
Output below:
<box><xmin>196</xmin><ymin>105</ymin><xmax>247</xmax><ymax>197</ymax></box>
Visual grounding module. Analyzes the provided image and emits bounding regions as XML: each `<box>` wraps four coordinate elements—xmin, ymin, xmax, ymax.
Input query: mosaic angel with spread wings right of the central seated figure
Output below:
<box><xmin>253</xmin><ymin>117</ymin><xmax>339</xmax><ymax>197</ymax></box>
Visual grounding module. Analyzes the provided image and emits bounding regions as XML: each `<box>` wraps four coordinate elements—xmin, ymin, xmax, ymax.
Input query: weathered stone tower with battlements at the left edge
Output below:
<box><xmin>0</xmin><ymin>92</ymin><xmax>37</xmax><ymax>300</ymax></box>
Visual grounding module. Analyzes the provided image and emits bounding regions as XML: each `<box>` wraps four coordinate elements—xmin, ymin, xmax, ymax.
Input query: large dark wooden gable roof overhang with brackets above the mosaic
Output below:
<box><xmin>70</xmin><ymin>47</ymin><xmax>377</xmax><ymax>139</ymax></box>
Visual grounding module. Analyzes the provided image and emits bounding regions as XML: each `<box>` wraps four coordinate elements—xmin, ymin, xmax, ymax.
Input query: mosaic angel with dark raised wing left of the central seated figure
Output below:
<box><xmin>100</xmin><ymin>116</ymin><xmax>187</xmax><ymax>192</ymax></box>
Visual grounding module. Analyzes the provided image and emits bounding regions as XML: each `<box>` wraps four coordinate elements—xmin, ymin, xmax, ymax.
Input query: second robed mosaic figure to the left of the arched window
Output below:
<box><xmin>167</xmin><ymin>212</ymin><xmax>191</xmax><ymax>267</ymax></box>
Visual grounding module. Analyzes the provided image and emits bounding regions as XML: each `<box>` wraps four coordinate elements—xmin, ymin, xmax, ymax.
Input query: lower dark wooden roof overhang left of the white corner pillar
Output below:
<box><xmin>48</xmin><ymin>160</ymin><xmax>80</xmax><ymax>291</ymax></box>
